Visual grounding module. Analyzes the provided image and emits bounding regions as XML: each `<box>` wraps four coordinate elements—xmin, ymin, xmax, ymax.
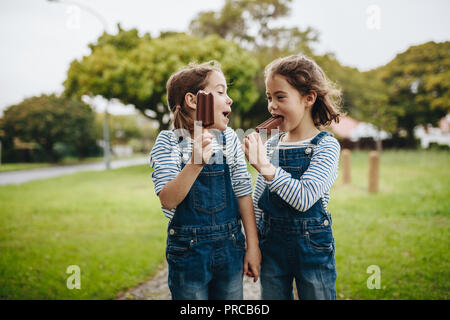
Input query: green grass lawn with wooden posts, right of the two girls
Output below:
<box><xmin>329</xmin><ymin>151</ymin><xmax>450</xmax><ymax>299</ymax></box>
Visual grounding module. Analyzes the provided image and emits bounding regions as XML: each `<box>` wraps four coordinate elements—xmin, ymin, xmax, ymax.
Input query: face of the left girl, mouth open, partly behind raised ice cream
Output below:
<box><xmin>204</xmin><ymin>71</ymin><xmax>233</xmax><ymax>131</ymax></box>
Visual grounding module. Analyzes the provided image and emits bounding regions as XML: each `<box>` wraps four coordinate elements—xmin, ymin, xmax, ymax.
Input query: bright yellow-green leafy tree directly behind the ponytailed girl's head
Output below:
<box><xmin>64</xmin><ymin>26</ymin><xmax>259</xmax><ymax>129</ymax></box>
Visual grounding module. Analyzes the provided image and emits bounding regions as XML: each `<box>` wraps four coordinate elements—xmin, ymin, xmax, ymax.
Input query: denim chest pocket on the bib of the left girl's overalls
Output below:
<box><xmin>193</xmin><ymin>170</ymin><xmax>226</xmax><ymax>214</ymax></box>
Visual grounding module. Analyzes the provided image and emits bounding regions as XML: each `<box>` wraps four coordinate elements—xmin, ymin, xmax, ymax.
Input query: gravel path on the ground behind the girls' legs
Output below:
<box><xmin>117</xmin><ymin>264</ymin><xmax>261</xmax><ymax>300</ymax></box>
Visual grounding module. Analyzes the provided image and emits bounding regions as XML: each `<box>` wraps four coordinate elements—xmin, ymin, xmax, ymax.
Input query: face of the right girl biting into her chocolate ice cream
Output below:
<box><xmin>266</xmin><ymin>74</ymin><xmax>314</xmax><ymax>132</ymax></box>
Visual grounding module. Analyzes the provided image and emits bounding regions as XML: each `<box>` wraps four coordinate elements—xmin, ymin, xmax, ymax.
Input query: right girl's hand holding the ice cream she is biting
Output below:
<box><xmin>242</xmin><ymin>132</ymin><xmax>273</xmax><ymax>175</ymax></box>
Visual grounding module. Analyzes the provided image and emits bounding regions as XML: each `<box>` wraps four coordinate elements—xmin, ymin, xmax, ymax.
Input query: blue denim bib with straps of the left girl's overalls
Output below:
<box><xmin>169</xmin><ymin>131</ymin><xmax>240</xmax><ymax>230</ymax></box>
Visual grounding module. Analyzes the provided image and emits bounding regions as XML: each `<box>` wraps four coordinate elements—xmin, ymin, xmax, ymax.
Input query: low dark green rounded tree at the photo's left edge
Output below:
<box><xmin>2</xmin><ymin>94</ymin><xmax>95</xmax><ymax>162</ymax></box>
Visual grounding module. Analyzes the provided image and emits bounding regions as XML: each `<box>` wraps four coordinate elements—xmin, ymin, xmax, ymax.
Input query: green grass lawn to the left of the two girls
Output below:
<box><xmin>0</xmin><ymin>166</ymin><xmax>167</xmax><ymax>299</ymax></box>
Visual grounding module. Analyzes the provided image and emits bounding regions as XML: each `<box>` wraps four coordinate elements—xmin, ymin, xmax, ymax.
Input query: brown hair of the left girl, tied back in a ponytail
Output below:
<box><xmin>166</xmin><ymin>60</ymin><xmax>222</xmax><ymax>132</ymax></box>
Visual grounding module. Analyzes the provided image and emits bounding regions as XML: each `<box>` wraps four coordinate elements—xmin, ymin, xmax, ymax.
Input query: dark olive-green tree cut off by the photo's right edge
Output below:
<box><xmin>376</xmin><ymin>41</ymin><xmax>450</xmax><ymax>141</ymax></box>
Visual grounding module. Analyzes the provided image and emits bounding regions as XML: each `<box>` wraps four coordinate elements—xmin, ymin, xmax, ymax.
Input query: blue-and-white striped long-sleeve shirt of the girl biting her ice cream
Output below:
<box><xmin>253</xmin><ymin>132</ymin><xmax>340</xmax><ymax>222</ymax></box>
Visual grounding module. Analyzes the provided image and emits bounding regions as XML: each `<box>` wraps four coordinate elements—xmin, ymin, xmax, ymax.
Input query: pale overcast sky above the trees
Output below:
<box><xmin>0</xmin><ymin>0</ymin><xmax>450</xmax><ymax>112</ymax></box>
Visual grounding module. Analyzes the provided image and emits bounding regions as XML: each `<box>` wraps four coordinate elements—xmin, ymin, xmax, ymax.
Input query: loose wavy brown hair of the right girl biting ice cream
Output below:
<box><xmin>264</xmin><ymin>55</ymin><xmax>341</xmax><ymax>127</ymax></box>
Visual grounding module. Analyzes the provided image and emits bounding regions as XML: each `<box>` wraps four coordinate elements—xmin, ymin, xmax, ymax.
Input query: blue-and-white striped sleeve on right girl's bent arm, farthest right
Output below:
<box><xmin>269</xmin><ymin>137</ymin><xmax>340</xmax><ymax>212</ymax></box>
